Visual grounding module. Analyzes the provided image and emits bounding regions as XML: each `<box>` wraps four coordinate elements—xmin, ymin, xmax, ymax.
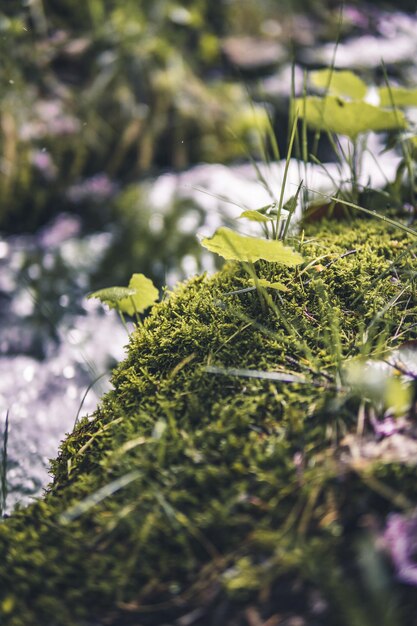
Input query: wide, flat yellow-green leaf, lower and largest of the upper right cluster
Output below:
<box><xmin>296</xmin><ymin>96</ymin><xmax>407</xmax><ymax>139</ymax></box>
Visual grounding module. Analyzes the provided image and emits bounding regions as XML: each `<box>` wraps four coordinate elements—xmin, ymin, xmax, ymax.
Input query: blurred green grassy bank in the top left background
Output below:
<box><xmin>0</xmin><ymin>0</ymin><xmax>282</xmax><ymax>228</ymax></box>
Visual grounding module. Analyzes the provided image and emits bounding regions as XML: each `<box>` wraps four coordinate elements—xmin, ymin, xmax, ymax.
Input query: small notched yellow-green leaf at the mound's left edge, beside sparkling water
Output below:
<box><xmin>88</xmin><ymin>274</ymin><xmax>159</xmax><ymax>315</ymax></box>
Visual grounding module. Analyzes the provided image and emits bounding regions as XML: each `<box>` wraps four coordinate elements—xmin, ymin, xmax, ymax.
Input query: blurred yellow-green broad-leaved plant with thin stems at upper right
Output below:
<box><xmin>293</xmin><ymin>67</ymin><xmax>417</xmax><ymax>205</ymax></box>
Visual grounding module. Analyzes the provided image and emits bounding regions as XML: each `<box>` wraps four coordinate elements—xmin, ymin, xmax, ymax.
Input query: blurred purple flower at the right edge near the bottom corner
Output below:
<box><xmin>383</xmin><ymin>513</ymin><xmax>417</xmax><ymax>587</ymax></box>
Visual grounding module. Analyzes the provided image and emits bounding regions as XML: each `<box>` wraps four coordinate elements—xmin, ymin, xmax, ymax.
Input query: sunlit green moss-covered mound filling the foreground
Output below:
<box><xmin>0</xmin><ymin>220</ymin><xmax>417</xmax><ymax>626</ymax></box>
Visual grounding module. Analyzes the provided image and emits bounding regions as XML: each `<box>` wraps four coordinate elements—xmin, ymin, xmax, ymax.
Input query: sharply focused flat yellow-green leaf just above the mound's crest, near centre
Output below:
<box><xmin>201</xmin><ymin>227</ymin><xmax>304</xmax><ymax>265</ymax></box>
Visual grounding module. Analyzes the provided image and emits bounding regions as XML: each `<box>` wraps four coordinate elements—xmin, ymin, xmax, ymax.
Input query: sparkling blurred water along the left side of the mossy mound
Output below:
<box><xmin>0</xmin><ymin>222</ymin><xmax>127</xmax><ymax>507</ymax></box>
